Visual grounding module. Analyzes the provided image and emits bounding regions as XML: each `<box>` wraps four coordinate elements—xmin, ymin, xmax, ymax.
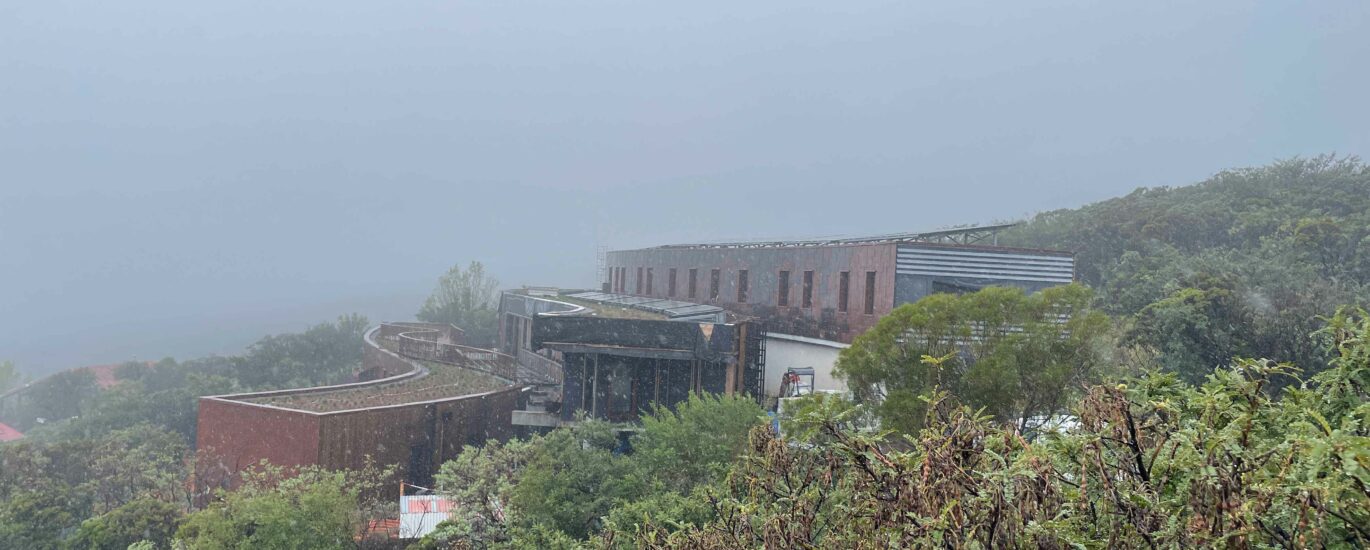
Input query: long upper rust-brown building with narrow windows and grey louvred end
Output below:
<box><xmin>604</xmin><ymin>233</ymin><xmax>1074</xmax><ymax>343</ymax></box>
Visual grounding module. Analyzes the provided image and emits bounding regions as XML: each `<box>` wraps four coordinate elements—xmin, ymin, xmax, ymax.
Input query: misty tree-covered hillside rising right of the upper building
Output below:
<box><xmin>1000</xmin><ymin>155</ymin><xmax>1370</xmax><ymax>377</ymax></box>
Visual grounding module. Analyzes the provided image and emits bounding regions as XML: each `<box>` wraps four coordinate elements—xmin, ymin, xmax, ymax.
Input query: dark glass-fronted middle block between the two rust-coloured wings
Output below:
<box><xmin>500</xmin><ymin>291</ymin><xmax>766</xmax><ymax>427</ymax></box>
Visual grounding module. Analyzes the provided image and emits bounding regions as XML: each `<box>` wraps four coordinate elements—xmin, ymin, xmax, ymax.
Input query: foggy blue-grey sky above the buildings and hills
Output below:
<box><xmin>0</xmin><ymin>0</ymin><xmax>1370</xmax><ymax>374</ymax></box>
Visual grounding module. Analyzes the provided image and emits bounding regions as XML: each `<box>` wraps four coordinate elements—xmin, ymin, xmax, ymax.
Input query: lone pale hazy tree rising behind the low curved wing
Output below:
<box><xmin>416</xmin><ymin>262</ymin><xmax>500</xmax><ymax>347</ymax></box>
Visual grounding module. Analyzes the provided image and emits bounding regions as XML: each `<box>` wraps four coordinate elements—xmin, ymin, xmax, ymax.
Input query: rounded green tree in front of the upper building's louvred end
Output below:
<box><xmin>836</xmin><ymin>284</ymin><xmax>1111</xmax><ymax>433</ymax></box>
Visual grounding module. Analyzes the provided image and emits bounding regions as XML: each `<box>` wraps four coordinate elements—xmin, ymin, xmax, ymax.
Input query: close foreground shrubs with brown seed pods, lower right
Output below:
<box><xmin>611</xmin><ymin>305</ymin><xmax>1370</xmax><ymax>549</ymax></box>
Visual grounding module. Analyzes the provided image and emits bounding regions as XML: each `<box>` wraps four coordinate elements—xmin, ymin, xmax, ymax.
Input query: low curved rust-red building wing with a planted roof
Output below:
<box><xmin>196</xmin><ymin>319</ymin><xmax>523</xmax><ymax>490</ymax></box>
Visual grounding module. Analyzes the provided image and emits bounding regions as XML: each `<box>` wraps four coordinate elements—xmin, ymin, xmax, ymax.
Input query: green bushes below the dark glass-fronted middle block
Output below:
<box><xmin>421</xmin><ymin>395</ymin><xmax>763</xmax><ymax>547</ymax></box>
